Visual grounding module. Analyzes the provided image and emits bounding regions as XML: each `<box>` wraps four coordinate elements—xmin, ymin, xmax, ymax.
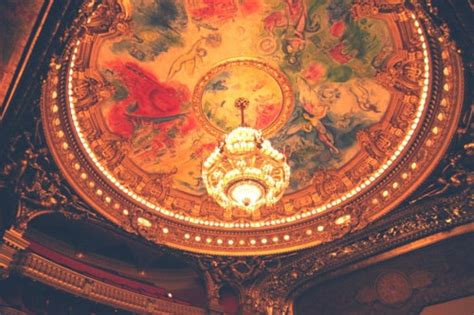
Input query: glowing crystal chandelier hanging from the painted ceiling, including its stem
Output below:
<box><xmin>202</xmin><ymin>98</ymin><xmax>290</xmax><ymax>212</ymax></box>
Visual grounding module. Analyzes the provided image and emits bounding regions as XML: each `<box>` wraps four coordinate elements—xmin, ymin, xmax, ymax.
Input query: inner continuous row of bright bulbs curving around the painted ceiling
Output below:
<box><xmin>65</xmin><ymin>14</ymin><xmax>432</xmax><ymax>228</ymax></box>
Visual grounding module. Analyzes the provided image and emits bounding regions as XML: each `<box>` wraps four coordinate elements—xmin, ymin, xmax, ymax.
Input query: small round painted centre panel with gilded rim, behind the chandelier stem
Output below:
<box><xmin>192</xmin><ymin>59</ymin><xmax>293</xmax><ymax>137</ymax></box>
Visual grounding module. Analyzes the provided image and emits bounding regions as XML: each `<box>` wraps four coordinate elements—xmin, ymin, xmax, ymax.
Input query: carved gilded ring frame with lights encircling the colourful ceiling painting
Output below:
<box><xmin>41</xmin><ymin>0</ymin><xmax>463</xmax><ymax>256</ymax></box>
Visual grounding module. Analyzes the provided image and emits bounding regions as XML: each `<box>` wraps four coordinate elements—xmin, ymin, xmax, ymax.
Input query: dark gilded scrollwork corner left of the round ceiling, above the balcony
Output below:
<box><xmin>0</xmin><ymin>120</ymin><xmax>98</xmax><ymax>235</ymax></box>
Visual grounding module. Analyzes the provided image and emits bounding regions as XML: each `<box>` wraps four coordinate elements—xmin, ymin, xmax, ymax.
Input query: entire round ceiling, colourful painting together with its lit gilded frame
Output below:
<box><xmin>42</xmin><ymin>0</ymin><xmax>462</xmax><ymax>254</ymax></box>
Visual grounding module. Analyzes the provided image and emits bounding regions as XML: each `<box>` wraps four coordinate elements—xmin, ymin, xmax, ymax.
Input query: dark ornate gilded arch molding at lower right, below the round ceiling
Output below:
<box><xmin>250</xmin><ymin>188</ymin><xmax>474</xmax><ymax>314</ymax></box>
